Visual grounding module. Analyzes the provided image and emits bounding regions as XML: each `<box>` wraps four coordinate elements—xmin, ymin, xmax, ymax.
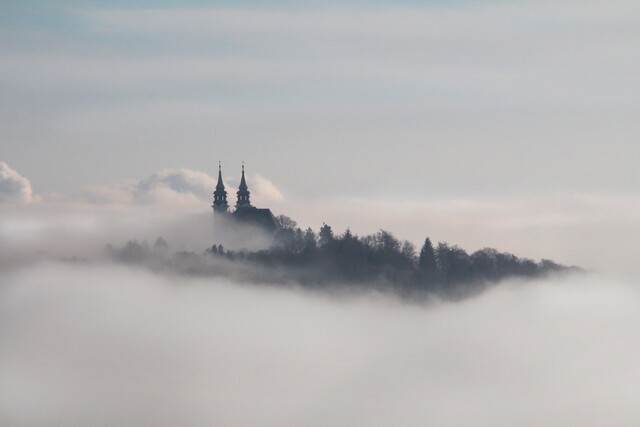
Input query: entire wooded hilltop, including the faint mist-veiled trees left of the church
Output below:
<box><xmin>105</xmin><ymin>216</ymin><xmax>578</xmax><ymax>299</ymax></box>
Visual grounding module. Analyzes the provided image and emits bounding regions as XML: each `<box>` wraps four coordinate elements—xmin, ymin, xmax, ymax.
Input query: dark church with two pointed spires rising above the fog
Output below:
<box><xmin>212</xmin><ymin>163</ymin><xmax>278</xmax><ymax>231</ymax></box>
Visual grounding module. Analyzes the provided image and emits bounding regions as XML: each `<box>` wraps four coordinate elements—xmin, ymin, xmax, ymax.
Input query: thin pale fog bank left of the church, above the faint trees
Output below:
<box><xmin>0</xmin><ymin>203</ymin><xmax>270</xmax><ymax>269</ymax></box>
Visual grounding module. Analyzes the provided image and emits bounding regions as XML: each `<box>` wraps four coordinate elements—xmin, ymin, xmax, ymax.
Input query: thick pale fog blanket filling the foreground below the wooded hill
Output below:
<box><xmin>0</xmin><ymin>262</ymin><xmax>640</xmax><ymax>426</ymax></box>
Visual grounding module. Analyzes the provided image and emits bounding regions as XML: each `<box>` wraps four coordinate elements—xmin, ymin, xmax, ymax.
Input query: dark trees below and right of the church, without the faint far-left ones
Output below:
<box><xmin>207</xmin><ymin>216</ymin><xmax>569</xmax><ymax>298</ymax></box>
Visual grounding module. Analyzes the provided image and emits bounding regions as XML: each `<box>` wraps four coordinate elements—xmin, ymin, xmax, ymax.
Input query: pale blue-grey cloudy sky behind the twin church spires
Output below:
<box><xmin>0</xmin><ymin>0</ymin><xmax>640</xmax><ymax>271</ymax></box>
